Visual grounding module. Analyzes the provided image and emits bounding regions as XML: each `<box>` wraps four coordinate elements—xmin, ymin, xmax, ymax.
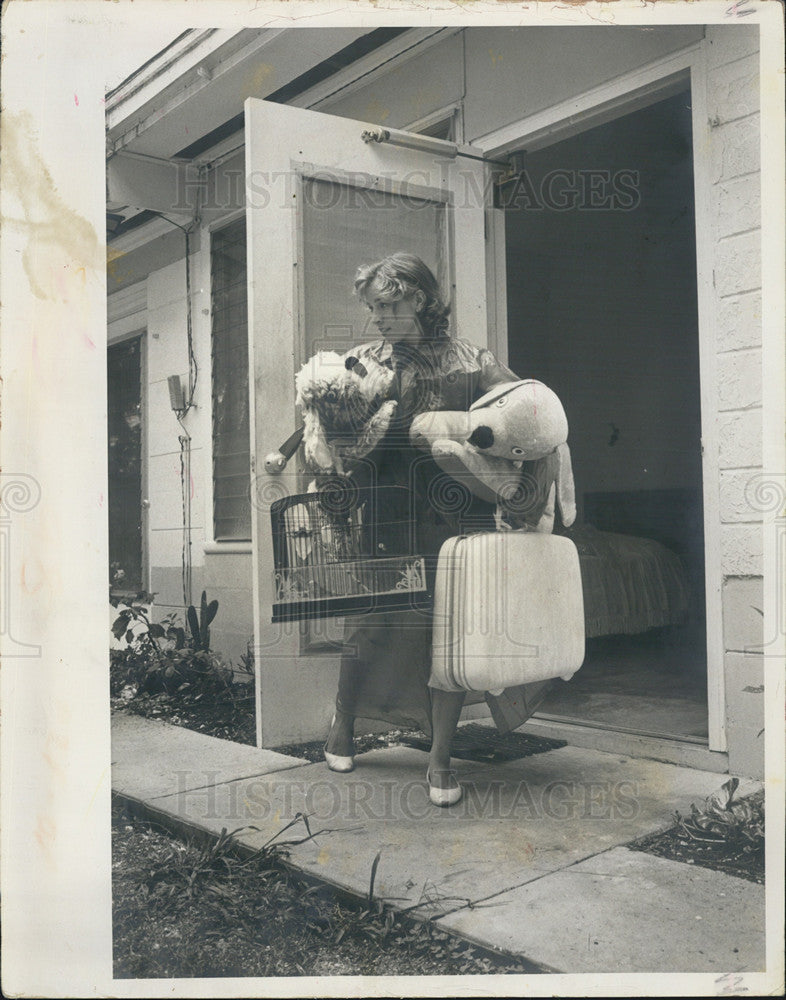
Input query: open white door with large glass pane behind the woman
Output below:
<box><xmin>245</xmin><ymin>99</ymin><xmax>490</xmax><ymax>746</ymax></box>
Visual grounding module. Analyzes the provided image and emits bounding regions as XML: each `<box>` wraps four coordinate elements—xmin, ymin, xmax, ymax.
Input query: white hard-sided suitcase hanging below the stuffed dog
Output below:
<box><xmin>431</xmin><ymin>531</ymin><xmax>584</xmax><ymax>692</ymax></box>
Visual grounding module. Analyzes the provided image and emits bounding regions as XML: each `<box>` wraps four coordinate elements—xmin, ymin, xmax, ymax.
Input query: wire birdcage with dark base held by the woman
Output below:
<box><xmin>271</xmin><ymin>478</ymin><xmax>432</xmax><ymax>622</ymax></box>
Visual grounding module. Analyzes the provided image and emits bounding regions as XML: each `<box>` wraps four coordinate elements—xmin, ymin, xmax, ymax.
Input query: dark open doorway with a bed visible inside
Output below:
<box><xmin>500</xmin><ymin>89</ymin><xmax>708</xmax><ymax>744</ymax></box>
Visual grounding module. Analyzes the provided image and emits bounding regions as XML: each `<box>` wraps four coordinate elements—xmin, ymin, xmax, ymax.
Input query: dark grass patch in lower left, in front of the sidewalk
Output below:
<box><xmin>112</xmin><ymin>801</ymin><xmax>537</xmax><ymax>979</ymax></box>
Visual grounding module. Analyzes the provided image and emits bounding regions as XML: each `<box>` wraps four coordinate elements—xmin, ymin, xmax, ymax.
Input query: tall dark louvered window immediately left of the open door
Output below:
<box><xmin>210</xmin><ymin>218</ymin><xmax>251</xmax><ymax>541</ymax></box>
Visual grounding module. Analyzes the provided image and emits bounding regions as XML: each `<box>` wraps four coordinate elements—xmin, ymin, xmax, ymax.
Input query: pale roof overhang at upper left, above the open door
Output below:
<box><xmin>106</xmin><ymin>26</ymin><xmax>422</xmax><ymax>235</ymax></box>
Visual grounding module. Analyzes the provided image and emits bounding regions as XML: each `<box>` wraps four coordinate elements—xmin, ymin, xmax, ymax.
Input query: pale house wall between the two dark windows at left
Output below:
<box><xmin>109</xmin><ymin>217</ymin><xmax>253</xmax><ymax>666</ymax></box>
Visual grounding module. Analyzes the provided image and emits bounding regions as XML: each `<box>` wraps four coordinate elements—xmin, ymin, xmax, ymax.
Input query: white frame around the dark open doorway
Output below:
<box><xmin>474</xmin><ymin>41</ymin><xmax>726</xmax><ymax>752</ymax></box>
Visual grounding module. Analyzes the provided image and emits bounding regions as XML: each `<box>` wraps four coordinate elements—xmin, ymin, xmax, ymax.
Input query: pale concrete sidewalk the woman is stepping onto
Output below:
<box><xmin>112</xmin><ymin>714</ymin><xmax>765</xmax><ymax>973</ymax></box>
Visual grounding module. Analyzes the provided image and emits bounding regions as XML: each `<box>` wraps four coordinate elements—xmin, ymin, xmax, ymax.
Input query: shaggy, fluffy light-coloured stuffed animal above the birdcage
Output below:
<box><xmin>295</xmin><ymin>351</ymin><xmax>397</xmax><ymax>474</ymax></box>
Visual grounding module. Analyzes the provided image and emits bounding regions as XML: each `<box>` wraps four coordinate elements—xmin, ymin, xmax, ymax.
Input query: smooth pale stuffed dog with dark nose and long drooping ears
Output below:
<box><xmin>410</xmin><ymin>379</ymin><xmax>576</xmax><ymax>532</ymax></box>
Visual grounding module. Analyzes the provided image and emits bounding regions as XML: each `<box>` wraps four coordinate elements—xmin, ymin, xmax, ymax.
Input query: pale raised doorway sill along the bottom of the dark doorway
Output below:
<box><xmin>517</xmin><ymin>714</ymin><xmax>729</xmax><ymax>774</ymax></box>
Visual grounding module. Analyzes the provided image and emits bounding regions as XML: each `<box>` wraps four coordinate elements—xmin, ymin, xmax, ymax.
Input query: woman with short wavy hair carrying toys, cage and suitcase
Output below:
<box><xmin>325</xmin><ymin>253</ymin><xmax>528</xmax><ymax>806</ymax></box>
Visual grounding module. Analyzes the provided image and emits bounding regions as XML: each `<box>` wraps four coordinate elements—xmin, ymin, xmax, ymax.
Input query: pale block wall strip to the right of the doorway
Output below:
<box><xmin>706</xmin><ymin>26</ymin><xmax>764</xmax><ymax>777</ymax></box>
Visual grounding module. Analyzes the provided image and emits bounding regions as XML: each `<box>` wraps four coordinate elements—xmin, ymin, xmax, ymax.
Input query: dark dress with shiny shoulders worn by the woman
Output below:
<box><xmin>336</xmin><ymin>336</ymin><xmax>548</xmax><ymax>733</ymax></box>
